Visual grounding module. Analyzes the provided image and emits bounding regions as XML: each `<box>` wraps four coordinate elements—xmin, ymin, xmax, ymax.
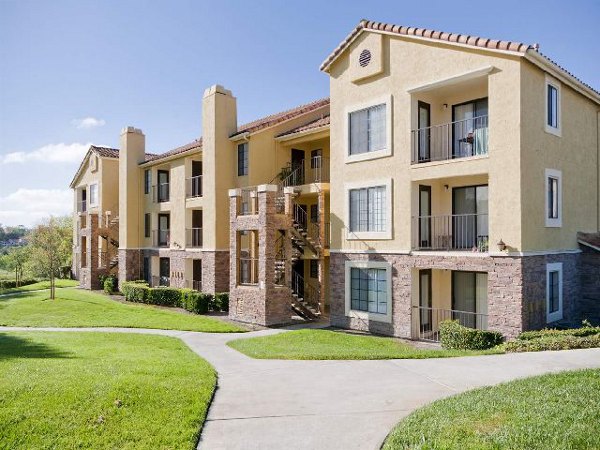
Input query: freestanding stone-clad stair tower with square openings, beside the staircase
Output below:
<box><xmin>229</xmin><ymin>190</ymin><xmax>292</xmax><ymax>326</ymax></box>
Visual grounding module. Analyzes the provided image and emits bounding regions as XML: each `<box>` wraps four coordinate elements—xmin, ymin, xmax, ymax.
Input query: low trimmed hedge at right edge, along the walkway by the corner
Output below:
<box><xmin>506</xmin><ymin>322</ymin><xmax>600</xmax><ymax>352</ymax></box>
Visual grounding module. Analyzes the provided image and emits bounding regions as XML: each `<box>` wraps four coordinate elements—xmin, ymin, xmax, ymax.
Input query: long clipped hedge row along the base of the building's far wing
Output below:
<box><xmin>121</xmin><ymin>281</ymin><xmax>229</xmax><ymax>314</ymax></box>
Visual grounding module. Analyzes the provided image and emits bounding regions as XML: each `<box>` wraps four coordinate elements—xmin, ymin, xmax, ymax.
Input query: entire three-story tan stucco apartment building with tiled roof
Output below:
<box><xmin>71</xmin><ymin>21</ymin><xmax>600</xmax><ymax>340</ymax></box>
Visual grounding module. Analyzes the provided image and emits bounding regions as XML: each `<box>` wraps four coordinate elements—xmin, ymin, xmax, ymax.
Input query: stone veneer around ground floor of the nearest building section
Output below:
<box><xmin>330</xmin><ymin>253</ymin><xmax>579</xmax><ymax>338</ymax></box>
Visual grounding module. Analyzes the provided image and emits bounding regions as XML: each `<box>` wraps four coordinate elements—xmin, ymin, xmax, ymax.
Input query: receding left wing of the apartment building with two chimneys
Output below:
<box><xmin>71</xmin><ymin>86</ymin><xmax>329</xmax><ymax>324</ymax></box>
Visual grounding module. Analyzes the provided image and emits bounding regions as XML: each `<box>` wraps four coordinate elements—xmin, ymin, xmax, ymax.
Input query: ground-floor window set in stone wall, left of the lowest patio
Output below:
<box><xmin>350</xmin><ymin>267</ymin><xmax>388</xmax><ymax>314</ymax></box>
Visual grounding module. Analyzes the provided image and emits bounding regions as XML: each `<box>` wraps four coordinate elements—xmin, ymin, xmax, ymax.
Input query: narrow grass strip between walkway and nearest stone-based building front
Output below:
<box><xmin>227</xmin><ymin>329</ymin><xmax>502</xmax><ymax>359</ymax></box>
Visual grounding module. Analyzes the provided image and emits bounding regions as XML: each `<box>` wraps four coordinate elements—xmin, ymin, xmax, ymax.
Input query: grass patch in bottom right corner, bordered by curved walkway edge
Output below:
<box><xmin>383</xmin><ymin>370</ymin><xmax>600</xmax><ymax>450</ymax></box>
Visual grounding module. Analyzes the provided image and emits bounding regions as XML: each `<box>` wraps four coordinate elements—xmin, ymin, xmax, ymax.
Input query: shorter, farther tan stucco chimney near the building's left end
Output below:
<box><xmin>119</xmin><ymin>127</ymin><xmax>146</xmax><ymax>249</ymax></box>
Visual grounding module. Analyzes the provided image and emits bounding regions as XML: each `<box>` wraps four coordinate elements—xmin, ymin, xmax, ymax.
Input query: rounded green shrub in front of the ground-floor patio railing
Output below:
<box><xmin>440</xmin><ymin>320</ymin><xmax>503</xmax><ymax>350</ymax></box>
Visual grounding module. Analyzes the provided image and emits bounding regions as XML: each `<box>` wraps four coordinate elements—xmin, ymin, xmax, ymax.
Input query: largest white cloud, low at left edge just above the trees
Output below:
<box><xmin>0</xmin><ymin>188</ymin><xmax>73</xmax><ymax>227</ymax></box>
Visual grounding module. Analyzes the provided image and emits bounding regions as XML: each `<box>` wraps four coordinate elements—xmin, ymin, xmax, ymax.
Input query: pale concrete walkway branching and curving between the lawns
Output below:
<box><xmin>0</xmin><ymin>327</ymin><xmax>600</xmax><ymax>450</ymax></box>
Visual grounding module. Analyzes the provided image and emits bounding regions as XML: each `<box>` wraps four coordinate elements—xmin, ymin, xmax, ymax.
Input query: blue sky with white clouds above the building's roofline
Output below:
<box><xmin>0</xmin><ymin>0</ymin><xmax>600</xmax><ymax>225</ymax></box>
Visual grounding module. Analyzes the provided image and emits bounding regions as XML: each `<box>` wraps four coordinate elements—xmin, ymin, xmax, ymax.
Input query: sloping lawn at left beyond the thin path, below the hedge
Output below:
<box><xmin>0</xmin><ymin>289</ymin><xmax>245</xmax><ymax>333</ymax></box>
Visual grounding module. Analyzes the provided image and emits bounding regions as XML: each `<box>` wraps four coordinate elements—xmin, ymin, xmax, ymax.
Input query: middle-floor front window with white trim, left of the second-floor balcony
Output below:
<box><xmin>349</xmin><ymin>186</ymin><xmax>386</xmax><ymax>232</ymax></box>
